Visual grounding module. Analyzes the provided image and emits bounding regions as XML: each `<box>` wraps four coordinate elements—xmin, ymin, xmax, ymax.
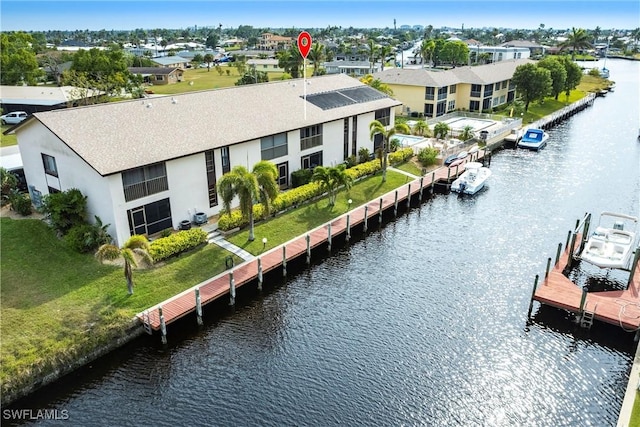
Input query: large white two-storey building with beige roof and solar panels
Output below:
<box><xmin>11</xmin><ymin>75</ymin><xmax>400</xmax><ymax>244</ymax></box>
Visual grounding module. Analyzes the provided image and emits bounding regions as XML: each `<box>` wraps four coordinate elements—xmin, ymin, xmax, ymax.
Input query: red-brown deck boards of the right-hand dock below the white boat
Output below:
<box><xmin>533</xmin><ymin>235</ymin><xmax>640</xmax><ymax>331</ymax></box>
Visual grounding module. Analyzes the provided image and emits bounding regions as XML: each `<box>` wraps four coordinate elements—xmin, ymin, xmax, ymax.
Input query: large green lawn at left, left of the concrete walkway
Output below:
<box><xmin>0</xmin><ymin>218</ymin><xmax>240</xmax><ymax>400</ymax></box>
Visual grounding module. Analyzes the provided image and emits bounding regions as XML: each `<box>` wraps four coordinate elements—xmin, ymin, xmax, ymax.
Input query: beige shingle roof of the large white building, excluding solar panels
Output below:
<box><xmin>31</xmin><ymin>75</ymin><xmax>402</xmax><ymax>175</ymax></box>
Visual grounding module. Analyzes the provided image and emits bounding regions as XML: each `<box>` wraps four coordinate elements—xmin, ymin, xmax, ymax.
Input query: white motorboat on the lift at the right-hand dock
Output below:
<box><xmin>580</xmin><ymin>212</ymin><xmax>638</xmax><ymax>269</ymax></box>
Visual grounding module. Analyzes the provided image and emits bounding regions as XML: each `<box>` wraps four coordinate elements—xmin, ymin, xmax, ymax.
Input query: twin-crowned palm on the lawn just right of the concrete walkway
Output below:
<box><xmin>218</xmin><ymin>160</ymin><xmax>279</xmax><ymax>242</ymax></box>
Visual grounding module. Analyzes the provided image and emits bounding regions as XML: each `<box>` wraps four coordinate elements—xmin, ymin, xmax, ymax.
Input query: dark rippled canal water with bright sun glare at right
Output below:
<box><xmin>10</xmin><ymin>59</ymin><xmax>640</xmax><ymax>426</ymax></box>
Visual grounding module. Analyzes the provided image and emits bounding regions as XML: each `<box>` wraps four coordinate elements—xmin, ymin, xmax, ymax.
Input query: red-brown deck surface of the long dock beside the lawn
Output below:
<box><xmin>137</xmin><ymin>151</ymin><xmax>486</xmax><ymax>330</ymax></box>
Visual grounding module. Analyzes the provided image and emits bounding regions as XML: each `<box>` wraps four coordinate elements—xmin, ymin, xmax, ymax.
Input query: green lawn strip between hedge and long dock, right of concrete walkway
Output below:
<box><xmin>227</xmin><ymin>171</ymin><xmax>413</xmax><ymax>255</ymax></box>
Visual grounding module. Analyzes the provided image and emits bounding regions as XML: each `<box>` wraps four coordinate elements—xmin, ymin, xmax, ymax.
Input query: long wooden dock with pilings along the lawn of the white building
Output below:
<box><xmin>137</xmin><ymin>150</ymin><xmax>488</xmax><ymax>342</ymax></box>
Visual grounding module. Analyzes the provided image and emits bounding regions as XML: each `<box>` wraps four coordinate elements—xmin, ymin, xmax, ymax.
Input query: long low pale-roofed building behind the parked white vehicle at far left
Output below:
<box><xmin>0</xmin><ymin>86</ymin><xmax>103</xmax><ymax>114</ymax></box>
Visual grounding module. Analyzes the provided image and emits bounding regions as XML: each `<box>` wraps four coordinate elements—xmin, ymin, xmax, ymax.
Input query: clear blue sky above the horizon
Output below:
<box><xmin>0</xmin><ymin>0</ymin><xmax>640</xmax><ymax>31</ymax></box>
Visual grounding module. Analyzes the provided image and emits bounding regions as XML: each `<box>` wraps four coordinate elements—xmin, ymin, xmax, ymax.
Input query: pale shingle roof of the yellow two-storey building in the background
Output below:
<box><xmin>373</xmin><ymin>59</ymin><xmax>534</xmax><ymax>87</ymax></box>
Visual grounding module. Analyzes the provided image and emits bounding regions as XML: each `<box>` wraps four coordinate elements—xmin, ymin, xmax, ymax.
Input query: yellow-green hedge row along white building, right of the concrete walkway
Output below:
<box><xmin>218</xmin><ymin>148</ymin><xmax>413</xmax><ymax>231</ymax></box>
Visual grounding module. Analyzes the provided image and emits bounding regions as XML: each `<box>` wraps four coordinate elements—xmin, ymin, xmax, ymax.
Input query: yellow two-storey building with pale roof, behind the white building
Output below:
<box><xmin>373</xmin><ymin>59</ymin><xmax>533</xmax><ymax>118</ymax></box>
